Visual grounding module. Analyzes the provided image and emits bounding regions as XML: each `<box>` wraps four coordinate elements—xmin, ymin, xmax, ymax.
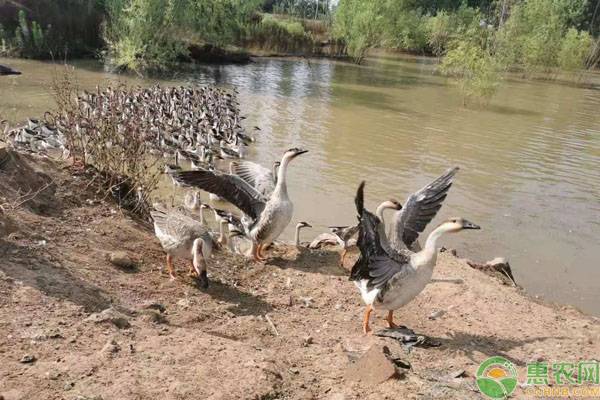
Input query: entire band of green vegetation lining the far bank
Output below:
<box><xmin>0</xmin><ymin>0</ymin><xmax>600</xmax><ymax>98</ymax></box>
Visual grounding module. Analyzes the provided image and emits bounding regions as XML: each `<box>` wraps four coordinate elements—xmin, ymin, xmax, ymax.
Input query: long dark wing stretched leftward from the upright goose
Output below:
<box><xmin>171</xmin><ymin>169</ymin><xmax>267</xmax><ymax>219</ymax></box>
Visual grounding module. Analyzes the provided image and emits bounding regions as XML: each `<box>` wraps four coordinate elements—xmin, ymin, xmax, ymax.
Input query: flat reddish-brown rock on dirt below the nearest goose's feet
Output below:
<box><xmin>345</xmin><ymin>345</ymin><xmax>396</xmax><ymax>385</ymax></box>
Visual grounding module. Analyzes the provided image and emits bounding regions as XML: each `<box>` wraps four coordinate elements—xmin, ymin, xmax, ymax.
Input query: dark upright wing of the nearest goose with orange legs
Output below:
<box><xmin>350</xmin><ymin>182</ymin><xmax>409</xmax><ymax>287</ymax></box>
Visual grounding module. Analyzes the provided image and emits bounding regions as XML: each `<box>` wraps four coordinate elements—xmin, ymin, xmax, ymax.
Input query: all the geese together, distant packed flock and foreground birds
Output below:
<box><xmin>0</xmin><ymin>66</ymin><xmax>480</xmax><ymax>334</ymax></box>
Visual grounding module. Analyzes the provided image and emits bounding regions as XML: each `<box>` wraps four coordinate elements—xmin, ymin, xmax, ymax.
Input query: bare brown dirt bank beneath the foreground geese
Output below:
<box><xmin>0</xmin><ymin>149</ymin><xmax>600</xmax><ymax>400</ymax></box>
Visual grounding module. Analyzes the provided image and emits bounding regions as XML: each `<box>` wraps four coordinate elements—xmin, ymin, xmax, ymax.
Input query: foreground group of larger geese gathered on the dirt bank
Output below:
<box><xmin>158</xmin><ymin>140</ymin><xmax>480</xmax><ymax>334</ymax></box>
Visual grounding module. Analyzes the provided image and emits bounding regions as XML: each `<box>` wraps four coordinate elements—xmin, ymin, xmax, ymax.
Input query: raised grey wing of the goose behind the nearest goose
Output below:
<box><xmin>390</xmin><ymin>167</ymin><xmax>458</xmax><ymax>248</ymax></box>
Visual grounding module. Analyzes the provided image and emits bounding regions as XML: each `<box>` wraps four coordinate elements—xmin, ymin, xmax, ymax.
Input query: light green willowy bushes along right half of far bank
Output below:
<box><xmin>334</xmin><ymin>0</ymin><xmax>600</xmax><ymax>99</ymax></box>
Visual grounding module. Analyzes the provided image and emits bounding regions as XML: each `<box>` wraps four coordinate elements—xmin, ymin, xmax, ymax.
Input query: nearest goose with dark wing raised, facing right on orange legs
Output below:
<box><xmin>350</xmin><ymin>181</ymin><xmax>480</xmax><ymax>334</ymax></box>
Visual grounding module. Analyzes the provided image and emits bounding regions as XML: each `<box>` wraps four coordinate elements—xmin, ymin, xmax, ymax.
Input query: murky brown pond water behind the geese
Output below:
<box><xmin>0</xmin><ymin>55</ymin><xmax>600</xmax><ymax>314</ymax></box>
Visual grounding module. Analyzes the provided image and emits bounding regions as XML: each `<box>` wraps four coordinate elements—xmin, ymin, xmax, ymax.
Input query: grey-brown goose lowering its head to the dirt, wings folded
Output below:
<box><xmin>150</xmin><ymin>204</ymin><xmax>214</xmax><ymax>288</ymax></box>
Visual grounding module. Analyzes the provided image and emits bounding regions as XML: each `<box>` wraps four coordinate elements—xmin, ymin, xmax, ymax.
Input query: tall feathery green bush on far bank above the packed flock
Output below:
<box><xmin>104</xmin><ymin>0</ymin><xmax>259</xmax><ymax>71</ymax></box>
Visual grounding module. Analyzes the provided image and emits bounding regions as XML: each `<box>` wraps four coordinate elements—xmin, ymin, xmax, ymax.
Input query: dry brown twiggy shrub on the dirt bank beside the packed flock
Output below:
<box><xmin>46</xmin><ymin>70</ymin><xmax>162</xmax><ymax>217</ymax></box>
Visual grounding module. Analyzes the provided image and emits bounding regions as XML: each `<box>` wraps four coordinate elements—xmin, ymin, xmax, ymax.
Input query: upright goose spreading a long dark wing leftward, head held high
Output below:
<box><xmin>173</xmin><ymin>148</ymin><xmax>308</xmax><ymax>261</ymax></box>
